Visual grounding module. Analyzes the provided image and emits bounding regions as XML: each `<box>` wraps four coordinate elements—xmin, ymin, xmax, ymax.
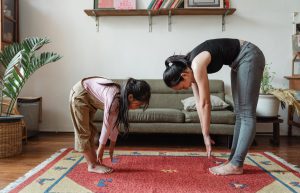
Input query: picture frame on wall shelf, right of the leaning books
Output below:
<box><xmin>184</xmin><ymin>0</ymin><xmax>224</xmax><ymax>9</ymax></box>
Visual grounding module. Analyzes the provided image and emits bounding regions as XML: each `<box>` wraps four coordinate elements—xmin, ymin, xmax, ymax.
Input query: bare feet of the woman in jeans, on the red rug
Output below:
<box><xmin>209</xmin><ymin>163</ymin><xmax>243</xmax><ymax>176</ymax></box>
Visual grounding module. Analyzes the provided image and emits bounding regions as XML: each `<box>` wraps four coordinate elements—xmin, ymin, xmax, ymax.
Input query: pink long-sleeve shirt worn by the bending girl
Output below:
<box><xmin>82</xmin><ymin>77</ymin><xmax>119</xmax><ymax>145</ymax></box>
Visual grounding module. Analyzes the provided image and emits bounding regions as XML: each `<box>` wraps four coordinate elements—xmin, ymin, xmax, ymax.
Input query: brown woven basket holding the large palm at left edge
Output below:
<box><xmin>0</xmin><ymin>119</ymin><xmax>23</xmax><ymax>158</ymax></box>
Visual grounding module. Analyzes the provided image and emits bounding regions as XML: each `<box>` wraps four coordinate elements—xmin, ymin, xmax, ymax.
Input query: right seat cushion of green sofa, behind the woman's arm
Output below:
<box><xmin>182</xmin><ymin>110</ymin><xmax>235</xmax><ymax>124</ymax></box>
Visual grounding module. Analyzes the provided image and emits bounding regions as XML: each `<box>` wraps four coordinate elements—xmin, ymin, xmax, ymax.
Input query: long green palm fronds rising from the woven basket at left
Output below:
<box><xmin>0</xmin><ymin>37</ymin><xmax>61</xmax><ymax>115</ymax></box>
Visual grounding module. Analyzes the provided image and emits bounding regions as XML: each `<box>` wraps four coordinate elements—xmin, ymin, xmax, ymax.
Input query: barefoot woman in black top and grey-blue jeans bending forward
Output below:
<box><xmin>163</xmin><ymin>39</ymin><xmax>265</xmax><ymax>175</ymax></box>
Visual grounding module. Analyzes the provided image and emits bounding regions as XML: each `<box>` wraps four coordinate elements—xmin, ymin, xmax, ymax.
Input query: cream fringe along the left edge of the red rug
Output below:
<box><xmin>0</xmin><ymin>148</ymin><xmax>67</xmax><ymax>193</ymax></box>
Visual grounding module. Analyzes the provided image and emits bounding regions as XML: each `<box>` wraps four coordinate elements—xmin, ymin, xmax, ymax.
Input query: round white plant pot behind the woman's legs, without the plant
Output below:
<box><xmin>256</xmin><ymin>94</ymin><xmax>280</xmax><ymax>117</ymax></box>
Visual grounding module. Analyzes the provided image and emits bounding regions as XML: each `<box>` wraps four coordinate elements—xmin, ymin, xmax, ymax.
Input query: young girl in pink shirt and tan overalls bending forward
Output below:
<box><xmin>70</xmin><ymin>77</ymin><xmax>151</xmax><ymax>173</ymax></box>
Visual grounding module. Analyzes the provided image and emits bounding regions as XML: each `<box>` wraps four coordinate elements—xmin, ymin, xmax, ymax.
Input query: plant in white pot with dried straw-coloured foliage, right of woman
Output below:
<box><xmin>256</xmin><ymin>64</ymin><xmax>300</xmax><ymax>117</ymax></box>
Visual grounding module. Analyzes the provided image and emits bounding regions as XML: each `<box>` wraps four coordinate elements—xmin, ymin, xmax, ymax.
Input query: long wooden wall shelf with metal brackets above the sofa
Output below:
<box><xmin>84</xmin><ymin>8</ymin><xmax>236</xmax><ymax>32</ymax></box>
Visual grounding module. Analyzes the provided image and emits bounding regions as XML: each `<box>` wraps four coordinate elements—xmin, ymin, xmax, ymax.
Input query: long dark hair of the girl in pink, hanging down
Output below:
<box><xmin>114</xmin><ymin>78</ymin><xmax>151</xmax><ymax>134</ymax></box>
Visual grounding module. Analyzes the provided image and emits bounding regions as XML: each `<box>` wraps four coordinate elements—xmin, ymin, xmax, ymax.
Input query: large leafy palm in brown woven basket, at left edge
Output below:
<box><xmin>0</xmin><ymin>37</ymin><xmax>61</xmax><ymax>158</ymax></box>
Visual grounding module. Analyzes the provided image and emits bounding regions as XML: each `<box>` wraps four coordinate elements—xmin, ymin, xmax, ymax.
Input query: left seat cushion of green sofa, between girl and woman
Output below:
<box><xmin>129</xmin><ymin>108</ymin><xmax>185</xmax><ymax>123</ymax></box>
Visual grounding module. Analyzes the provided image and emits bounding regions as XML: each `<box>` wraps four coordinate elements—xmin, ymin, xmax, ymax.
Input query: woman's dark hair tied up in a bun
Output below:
<box><xmin>163</xmin><ymin>55</ymin><xmax>191</xmax><ymax>87</ymax></box>
